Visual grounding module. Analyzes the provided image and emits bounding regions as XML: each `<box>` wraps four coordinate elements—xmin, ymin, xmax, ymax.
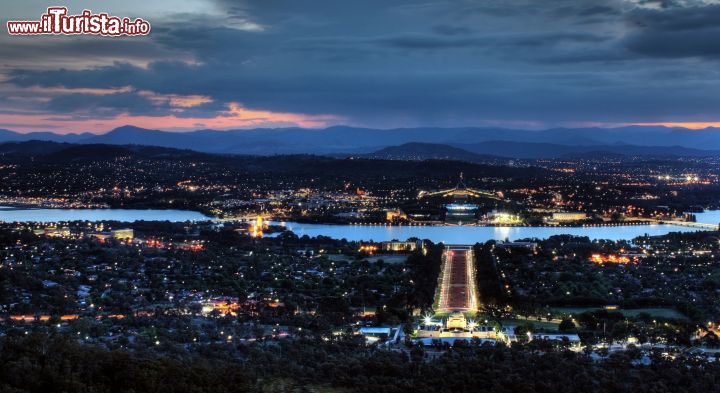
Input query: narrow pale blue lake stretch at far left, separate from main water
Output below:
<box><xmin>0</xmin><ymin>206</ymin><xmax>211</xmax><ymax>222</ymax></box>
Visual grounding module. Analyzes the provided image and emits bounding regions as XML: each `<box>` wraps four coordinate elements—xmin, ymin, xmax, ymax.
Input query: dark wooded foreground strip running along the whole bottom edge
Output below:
<box><xmin>0</xmin><ymin>335</ymin><xmax>720</xmax><ymax>393</ymax></box>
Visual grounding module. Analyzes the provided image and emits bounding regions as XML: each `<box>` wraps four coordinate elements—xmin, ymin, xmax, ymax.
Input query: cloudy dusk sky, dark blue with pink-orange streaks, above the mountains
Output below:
<box><xmin>0</xmin><ymin>0</ymin><xmax>720</xmax><ymax>132</ymax></box>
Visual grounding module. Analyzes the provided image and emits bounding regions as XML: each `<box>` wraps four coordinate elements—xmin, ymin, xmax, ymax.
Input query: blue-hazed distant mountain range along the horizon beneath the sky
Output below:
<box><xmin>0</xmin><ymin>126</ymin><xmax>720</xmax><ymax>161</ymax></box>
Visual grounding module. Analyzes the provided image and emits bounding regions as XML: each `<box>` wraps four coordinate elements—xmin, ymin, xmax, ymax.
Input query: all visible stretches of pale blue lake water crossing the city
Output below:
<box><xmin>0</xmin><ymin>206</ymin><xmax>720</xmax><ymax>244</ymax></box>
